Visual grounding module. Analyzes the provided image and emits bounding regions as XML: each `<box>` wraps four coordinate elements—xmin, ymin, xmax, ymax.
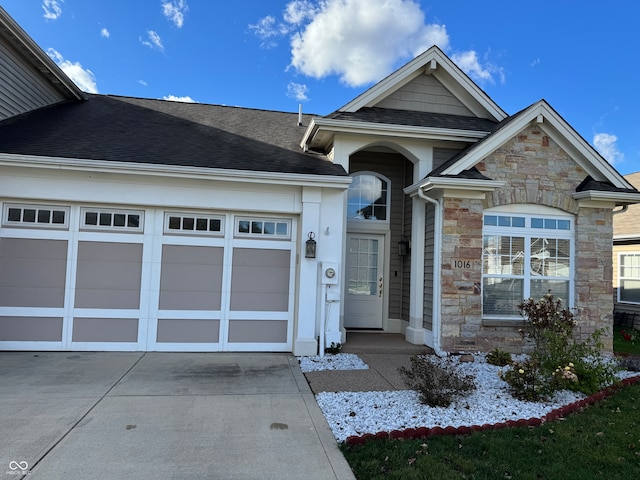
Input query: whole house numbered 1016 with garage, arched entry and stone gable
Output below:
<box><xmin>0</xmin><ymin>5</ymin><xmax>640</xmax><ymax>355</ymax></box>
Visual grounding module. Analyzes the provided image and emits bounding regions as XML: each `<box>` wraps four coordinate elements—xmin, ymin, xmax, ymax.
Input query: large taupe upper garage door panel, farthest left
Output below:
<box><xmin>0</xmin><ymin>238</ymin><xmax>67</xmax><ymax>308</ymax></box>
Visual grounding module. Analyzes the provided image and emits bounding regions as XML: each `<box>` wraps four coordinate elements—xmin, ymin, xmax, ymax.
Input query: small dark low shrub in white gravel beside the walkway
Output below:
<box><xmin>398</xmin><ymin>354</ymin><xmax>476</xmax><ymax>407</ymax></box>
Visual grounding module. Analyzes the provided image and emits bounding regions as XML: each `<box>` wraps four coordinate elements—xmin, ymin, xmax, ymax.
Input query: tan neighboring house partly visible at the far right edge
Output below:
<box><xmin>613</xmin><ymin>172</ymin><xmax>640</xmax><ymax>325</ymax></box>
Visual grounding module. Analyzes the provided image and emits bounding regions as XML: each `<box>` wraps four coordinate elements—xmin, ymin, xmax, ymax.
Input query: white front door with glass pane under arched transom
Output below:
<box><xmin>344</xmin><ymin>234</ymin><xmax>384</xmax><ymax>329</ymax></box>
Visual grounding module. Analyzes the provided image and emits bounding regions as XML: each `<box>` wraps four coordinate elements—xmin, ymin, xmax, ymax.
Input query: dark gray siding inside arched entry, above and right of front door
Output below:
<box><xmin>349</xmin><ymin>152</ymin><xmax>413</xmax><ymax>320</ymax></box>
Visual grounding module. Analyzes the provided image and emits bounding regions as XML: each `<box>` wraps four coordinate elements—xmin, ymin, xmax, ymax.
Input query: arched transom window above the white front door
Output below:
<box><xmin>347</xmin><ymin>172</ymin><xmax>390</xmax><ymax>221</ymax></box>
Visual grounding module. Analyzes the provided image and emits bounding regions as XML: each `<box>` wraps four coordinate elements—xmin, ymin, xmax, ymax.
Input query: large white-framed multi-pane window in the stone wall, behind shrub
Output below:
<box><xmin>482</xmin><ymin>212</ymin><xmax>574</xmax><ymax>318</ymax></box>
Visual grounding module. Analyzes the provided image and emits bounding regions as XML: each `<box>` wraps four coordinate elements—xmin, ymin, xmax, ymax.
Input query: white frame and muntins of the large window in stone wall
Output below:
<box><xmin>482</xmin><ymin>210</ymin><xmax>576</xmax><ymax>321</ymax></box>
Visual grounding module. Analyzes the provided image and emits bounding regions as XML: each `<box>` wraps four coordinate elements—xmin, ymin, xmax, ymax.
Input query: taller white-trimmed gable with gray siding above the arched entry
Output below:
<box><xmin>339</xmin><ymin>46</ymin><xmax>507</xmax><ymax>121</ymax></box>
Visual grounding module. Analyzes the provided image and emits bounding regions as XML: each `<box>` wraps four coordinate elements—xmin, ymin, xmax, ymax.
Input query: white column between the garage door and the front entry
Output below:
<box><xmin>293</xmin><ymin>187</ymin><xmax>322</xmax><ymax>356</ymax></box>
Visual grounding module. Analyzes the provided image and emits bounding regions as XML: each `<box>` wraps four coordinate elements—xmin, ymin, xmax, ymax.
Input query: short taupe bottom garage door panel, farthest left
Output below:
<box><xmin>0</xmin><ymin>317</ymin><xmax>62</xmax><ymax>342</ymax></box>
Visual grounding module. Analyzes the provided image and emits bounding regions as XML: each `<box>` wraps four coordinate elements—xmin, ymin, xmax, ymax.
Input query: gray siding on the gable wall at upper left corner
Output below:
<box><xmin>0</xmin><ymin>43</ymin><xmax>65</xmax><ymax>120</ymax></box>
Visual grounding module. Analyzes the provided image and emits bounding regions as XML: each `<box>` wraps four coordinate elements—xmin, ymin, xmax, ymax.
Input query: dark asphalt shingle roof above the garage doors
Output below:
<box><xmin>0</xmin><ymin>95</ymin><xmax>346</xmax><ymax>175</ymax></box>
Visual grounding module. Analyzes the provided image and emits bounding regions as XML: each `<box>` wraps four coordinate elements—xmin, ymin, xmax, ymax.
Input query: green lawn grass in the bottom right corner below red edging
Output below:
<box><xmin>341</xmin><ymin>384</ymin><xmax>640</xmax><ymax>480</ymax></box>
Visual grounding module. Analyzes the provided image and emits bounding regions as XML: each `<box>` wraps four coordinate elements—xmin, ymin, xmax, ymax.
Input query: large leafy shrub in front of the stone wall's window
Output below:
<box><xmin>501</xmin><ymin>294</ymin><xmax>619</xmax><ymax>401</ymax></box>
